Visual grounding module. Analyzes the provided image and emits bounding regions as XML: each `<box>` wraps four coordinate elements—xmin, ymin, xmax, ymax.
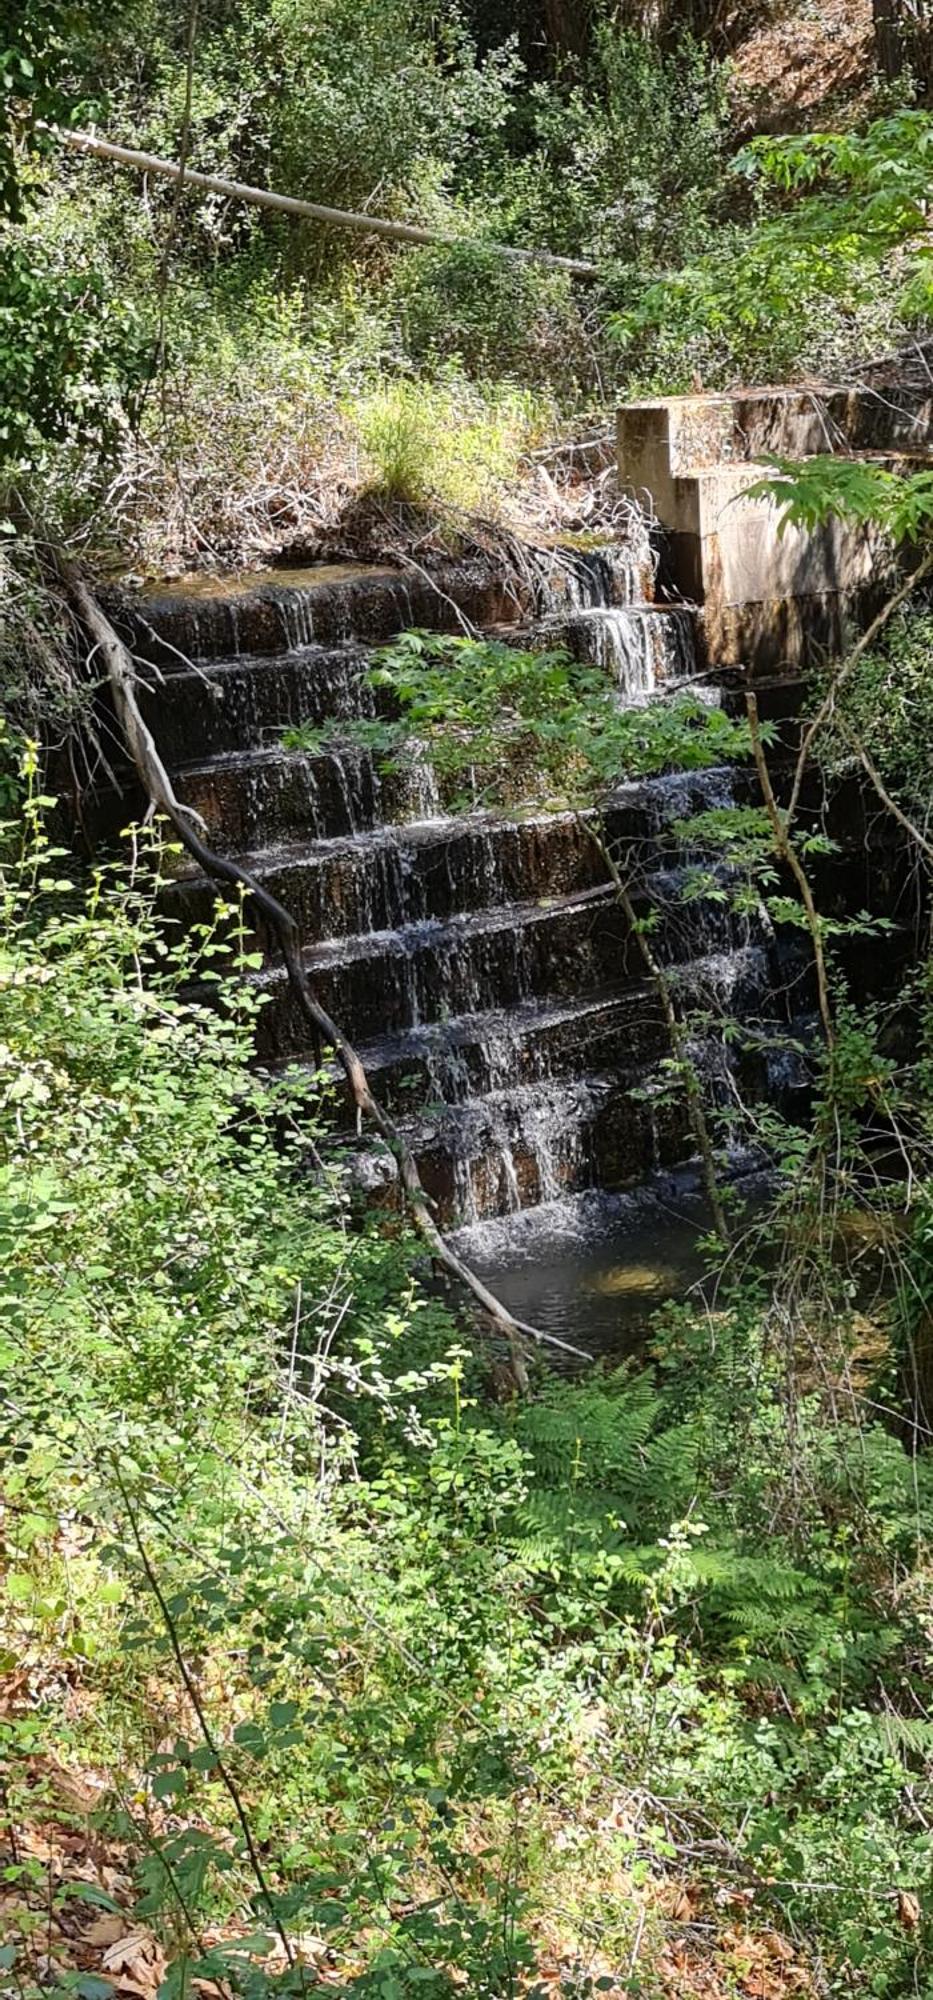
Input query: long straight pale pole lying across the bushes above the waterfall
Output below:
<box><xmin>56</xmin><ymin>126</ymin><xmax>599</xmax><ymax>278</ymax></box>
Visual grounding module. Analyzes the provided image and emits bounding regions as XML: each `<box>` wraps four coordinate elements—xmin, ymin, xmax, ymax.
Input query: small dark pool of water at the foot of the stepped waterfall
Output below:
<box><xmin>452</xmin><ymin>1176</ymin><xmax>728</xmax><ymax>1358</ymax></box>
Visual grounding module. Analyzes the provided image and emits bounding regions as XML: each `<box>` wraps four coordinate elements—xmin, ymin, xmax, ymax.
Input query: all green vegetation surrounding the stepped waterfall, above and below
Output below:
<box><xmin>0</xmin><ymin>0</ymin><xmax>933</xmax><ymax>2000</ymax></box>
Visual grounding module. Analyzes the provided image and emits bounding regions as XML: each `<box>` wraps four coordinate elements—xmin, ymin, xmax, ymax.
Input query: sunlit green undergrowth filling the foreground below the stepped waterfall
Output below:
<box><xmin>0</xmin><ymin>600</ymin><xmax>933</xmax><ymax>2000</ymax></box>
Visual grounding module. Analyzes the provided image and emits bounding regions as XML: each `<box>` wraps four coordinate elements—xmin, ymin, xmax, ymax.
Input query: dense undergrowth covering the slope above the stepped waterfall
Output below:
<box><xmin>0</xmin><ymin>0</ymin><xmax>927</xmax><ymax>568</ymax></box>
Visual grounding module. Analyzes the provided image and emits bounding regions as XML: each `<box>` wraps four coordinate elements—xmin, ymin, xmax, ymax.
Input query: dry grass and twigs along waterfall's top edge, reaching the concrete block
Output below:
<box><xmin>58</xmin><ymin>336</ymin><xmax>644</xmax><ymax>578</ymax></box>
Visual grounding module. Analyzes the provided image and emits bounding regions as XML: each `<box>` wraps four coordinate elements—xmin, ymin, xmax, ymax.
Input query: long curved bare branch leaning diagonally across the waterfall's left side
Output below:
<box><xmin>48</xmin><ymin>548</ymin><xmax>593</xmax><ymax>1392</ymax></box>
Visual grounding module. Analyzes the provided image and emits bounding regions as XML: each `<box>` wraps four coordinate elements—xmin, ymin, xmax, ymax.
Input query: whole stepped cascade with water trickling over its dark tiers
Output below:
<box><xmin>120</xmin><ymin>538</ymin><xmax>804</xmax><ymax>1224</ymax></box>
